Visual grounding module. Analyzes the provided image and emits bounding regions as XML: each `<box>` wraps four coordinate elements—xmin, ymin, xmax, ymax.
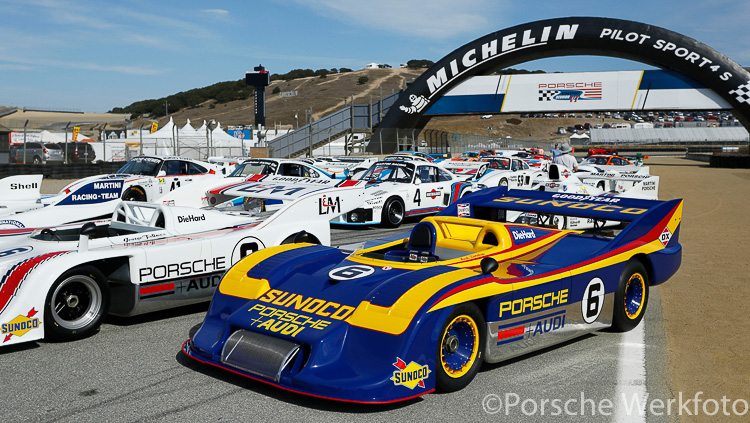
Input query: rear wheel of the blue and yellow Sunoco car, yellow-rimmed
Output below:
<box><xmin>612</xmin><ymin>260</ymin><xmax>649</xmax><ymax>332</ymax></box>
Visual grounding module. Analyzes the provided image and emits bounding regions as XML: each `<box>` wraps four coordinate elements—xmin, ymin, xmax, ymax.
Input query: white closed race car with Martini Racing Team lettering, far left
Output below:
<box><xmin>61</xmin><ymin>156</ymin><xmax>229</xmax><ymax>202</ymax></box>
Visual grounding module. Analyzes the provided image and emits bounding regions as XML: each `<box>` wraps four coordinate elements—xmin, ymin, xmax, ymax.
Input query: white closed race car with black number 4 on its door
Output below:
<box><xmin>331</xmin><ymin>160</ymin><xmax>469</xmax><ymax>228</ymax></box>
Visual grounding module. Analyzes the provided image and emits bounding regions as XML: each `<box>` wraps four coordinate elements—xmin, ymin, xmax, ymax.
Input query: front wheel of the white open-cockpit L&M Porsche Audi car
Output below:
<box><xmin>44</xmin><ymin>266</ymin><xmax>110</xmax><ymax>341</ymax></box>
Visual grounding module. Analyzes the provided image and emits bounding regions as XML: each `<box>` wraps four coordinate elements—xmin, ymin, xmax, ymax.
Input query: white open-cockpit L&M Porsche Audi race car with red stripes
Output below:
<box><xmin>0</xmin><ymin>184</ymin><xmax>362</xmax><ymax>346</ymax></box>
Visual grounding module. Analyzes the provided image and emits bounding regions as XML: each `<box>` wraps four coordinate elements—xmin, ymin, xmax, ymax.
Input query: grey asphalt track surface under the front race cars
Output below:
<box><xmin>0</xmin><ymin>222</ymin><xmax>670</xmax><ymax>422</ymax></box>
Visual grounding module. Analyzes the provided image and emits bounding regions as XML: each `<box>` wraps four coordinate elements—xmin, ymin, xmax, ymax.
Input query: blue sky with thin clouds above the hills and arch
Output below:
<box><xmin>0</xmin><ymin>0</ymin><xmax>750</xmax><ymax>112</ymax></box>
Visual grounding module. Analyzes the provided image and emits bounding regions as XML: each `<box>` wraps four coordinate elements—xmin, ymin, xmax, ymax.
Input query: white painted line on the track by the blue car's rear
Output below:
<box><xmin>613</xmin><ymin>321</ymin><xmax>648</xmax><ymax>423</ymax></box>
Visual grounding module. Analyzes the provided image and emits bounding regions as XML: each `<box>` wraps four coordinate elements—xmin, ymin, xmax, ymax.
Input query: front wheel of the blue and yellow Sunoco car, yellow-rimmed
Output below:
<box><xmin>435</xmin><ymin>303</ymin><xmax>487</xmax><ymax>392</ymax></box>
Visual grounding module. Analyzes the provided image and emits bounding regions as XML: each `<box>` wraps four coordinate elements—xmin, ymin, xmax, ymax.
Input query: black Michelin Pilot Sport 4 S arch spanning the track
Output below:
<box><xmin>367</xmin><ymin>17</ymin><xmax>750</xmax><ymax>154</ymax></box>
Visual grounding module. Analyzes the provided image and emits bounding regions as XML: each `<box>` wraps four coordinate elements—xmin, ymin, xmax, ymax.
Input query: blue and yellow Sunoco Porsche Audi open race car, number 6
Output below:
<box><xmin>183</xmin><ymin>187</ymin><xmax>682</xmax><ymax>403</ymax></box>
